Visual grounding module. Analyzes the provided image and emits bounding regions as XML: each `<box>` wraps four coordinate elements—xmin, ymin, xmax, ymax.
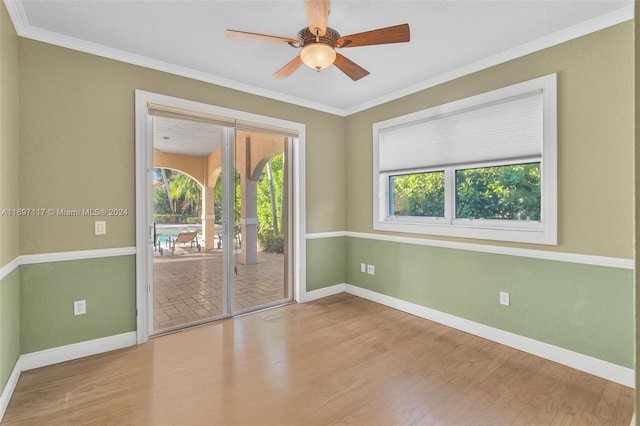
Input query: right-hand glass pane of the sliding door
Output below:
<box><xmin>232</xmin><ymin>132</ymin><xmax>291</xmax><ymax>313</ymax></box>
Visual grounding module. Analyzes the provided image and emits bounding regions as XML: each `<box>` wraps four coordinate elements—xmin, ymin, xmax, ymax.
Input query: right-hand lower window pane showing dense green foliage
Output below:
<box><xmin>456</xmin><ymin>162</ymin><xmax>540</xmax><ymax>221</ymax></box>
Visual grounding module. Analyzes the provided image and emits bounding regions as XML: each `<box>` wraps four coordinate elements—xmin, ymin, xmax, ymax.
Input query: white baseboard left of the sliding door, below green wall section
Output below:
<box><xmin>18</xmin><ymin>331</ymin><xmax>136</xmax><ymax>371</ymax></box>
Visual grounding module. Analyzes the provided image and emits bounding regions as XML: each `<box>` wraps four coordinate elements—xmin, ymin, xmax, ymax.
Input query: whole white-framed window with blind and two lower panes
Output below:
<box><xmin>373</xmin><ymin>74</ymin><xmax>557</xmax><ymax>244</ymax></box>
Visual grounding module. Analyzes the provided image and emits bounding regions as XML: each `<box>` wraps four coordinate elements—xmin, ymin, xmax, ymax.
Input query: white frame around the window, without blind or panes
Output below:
<box><xmin>372</xmin><ymin>74</ymin><xmax>557</xmax><ymax>245</ymax></box>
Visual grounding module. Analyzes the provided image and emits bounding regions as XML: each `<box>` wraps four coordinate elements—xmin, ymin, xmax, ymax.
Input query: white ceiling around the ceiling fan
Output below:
<box><xmin>5</xmin><ymin>0</ymin><xmax>633</xmax><ymax>115</ymax></box>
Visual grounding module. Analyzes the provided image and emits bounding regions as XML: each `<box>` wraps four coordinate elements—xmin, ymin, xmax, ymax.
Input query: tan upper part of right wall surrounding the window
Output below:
<box><xmin>345</xmin><ymin>22</ymin><xmax>634</xmax><ymax>259</ymax></box>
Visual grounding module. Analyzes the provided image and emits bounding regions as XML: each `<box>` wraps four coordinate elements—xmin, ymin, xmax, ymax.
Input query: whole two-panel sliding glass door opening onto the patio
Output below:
<box><xmin>148</xmin><ymin>108</ymin><xmax>292</xmax><ymax>335</ymax></box>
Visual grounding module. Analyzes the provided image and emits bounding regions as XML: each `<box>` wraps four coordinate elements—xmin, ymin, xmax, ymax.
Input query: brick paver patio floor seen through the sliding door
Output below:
<box><xmin>153</xmin><ymin>246</ymin><xmax>290</xmax><ymax>332</ymax></box>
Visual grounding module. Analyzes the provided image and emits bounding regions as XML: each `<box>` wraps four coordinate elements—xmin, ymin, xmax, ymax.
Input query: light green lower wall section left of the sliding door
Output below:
<box><xmin>20</xmin><ymin>256</ymin><xmax>136</xmax><ymax>353</ymax></box>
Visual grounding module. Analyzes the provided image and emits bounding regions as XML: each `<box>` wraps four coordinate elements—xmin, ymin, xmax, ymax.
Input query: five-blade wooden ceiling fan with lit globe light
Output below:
<box><xmin>227</xmin><ymin>0</ymin><xmax>410</xmax><ymax>81</ymax></box>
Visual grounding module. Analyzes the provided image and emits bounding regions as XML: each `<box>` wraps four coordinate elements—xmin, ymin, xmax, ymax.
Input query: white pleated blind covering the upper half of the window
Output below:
<box><xmin>378</xmin><ymin>90</ymin><xmax>544</xmax><ymax>172</ymax></box>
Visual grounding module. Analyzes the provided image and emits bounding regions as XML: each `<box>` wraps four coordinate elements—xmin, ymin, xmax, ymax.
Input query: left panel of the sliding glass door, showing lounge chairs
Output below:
<box><xmin>151</xmin><ymin>116</ymin><xmax>233</xmax><ymax>334</ymax></box>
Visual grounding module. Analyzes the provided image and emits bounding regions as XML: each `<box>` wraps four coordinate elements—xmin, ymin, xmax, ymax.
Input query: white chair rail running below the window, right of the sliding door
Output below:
<box><xmin>307</xmin><ymin>231</ymin><xmax>635</xmax><ymax>270</ymax></box>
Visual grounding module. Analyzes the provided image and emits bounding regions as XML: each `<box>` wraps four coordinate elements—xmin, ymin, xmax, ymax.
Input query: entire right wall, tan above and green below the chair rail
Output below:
<box><xmin>345</xmin><ymin>22</ymin><xmax>636</xmax><ymax>368</ymax></box>
